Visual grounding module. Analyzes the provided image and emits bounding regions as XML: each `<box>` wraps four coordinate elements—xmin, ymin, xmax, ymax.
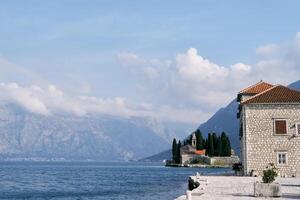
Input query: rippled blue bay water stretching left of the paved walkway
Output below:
<box><xmin>0</xmin><ymin>162</ymin><xmax>230</xmax><ymax>200</ymax></box>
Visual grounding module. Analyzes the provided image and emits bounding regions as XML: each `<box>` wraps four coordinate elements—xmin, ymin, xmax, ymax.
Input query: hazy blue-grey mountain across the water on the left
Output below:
<box><xmin>0</xmin><ymin>103</ymin><xmax>178</xmax><ymax>160</ymax></box>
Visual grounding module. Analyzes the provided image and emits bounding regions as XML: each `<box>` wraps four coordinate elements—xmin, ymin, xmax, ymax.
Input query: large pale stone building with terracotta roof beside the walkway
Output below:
<box><xmin>237</xmin><ymin>81</ymin><xmax>300</xmax><ymax>177</ymax></box>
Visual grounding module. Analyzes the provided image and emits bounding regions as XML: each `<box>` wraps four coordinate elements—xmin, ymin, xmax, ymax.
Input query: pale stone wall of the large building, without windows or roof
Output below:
<box><xmin>241</xmin><ymin>104</ymin><xmax>300</xmax><ymax>176</ymax></box>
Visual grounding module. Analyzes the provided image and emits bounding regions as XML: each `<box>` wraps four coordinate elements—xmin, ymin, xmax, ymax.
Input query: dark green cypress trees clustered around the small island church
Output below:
<box><xmin>172</xmin><ymin>129</ymin><xmax>231</xmax><ymax>163</ymax></box>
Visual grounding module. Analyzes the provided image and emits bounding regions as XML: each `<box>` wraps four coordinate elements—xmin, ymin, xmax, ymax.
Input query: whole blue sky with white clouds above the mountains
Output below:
<box><xmin>0</xmin><ymin>0</ymin><xmax>300</xmax><ymax>124</ymax></box>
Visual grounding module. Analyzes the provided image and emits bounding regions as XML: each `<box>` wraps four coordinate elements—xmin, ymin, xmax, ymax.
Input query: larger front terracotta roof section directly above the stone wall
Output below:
<box><xmin>241</xmin><ymin>85</ymin><xmax>300</xmax><ymax>104</ymax></box>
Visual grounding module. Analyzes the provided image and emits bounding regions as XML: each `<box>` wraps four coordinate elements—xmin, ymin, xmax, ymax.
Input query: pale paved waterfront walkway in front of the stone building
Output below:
<box><xmin>176</xmin><ymin>176</ymin><xmax>300</xmax><ymax>200</ymax></box>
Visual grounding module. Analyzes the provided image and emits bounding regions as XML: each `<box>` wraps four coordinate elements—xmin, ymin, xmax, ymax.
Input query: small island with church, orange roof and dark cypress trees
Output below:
<box><xmin>166</xmin><ymin>129</ymin><xmax>239</xmax><ymax>167</ymax></box>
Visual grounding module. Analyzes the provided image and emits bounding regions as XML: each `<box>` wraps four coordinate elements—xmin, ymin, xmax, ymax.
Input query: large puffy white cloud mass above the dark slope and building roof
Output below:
<box><xmin>116</xmin><ymin>32</ymin><xmax>300</xmax><ymax>122</ymax></box>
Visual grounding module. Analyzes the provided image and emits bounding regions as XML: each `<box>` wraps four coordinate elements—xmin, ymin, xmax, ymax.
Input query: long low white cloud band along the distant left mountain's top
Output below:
<box><xmin>0</xmin><ymin>83</ymin><xmax>203</xmax><ymax>123</ymax></box>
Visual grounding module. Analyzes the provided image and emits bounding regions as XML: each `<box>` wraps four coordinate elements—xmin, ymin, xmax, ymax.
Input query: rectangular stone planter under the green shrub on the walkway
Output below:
<box><xmin>254</xmin><ymin>182</ymin><xmax>282</xmax><ymax>197</ymax></box>
